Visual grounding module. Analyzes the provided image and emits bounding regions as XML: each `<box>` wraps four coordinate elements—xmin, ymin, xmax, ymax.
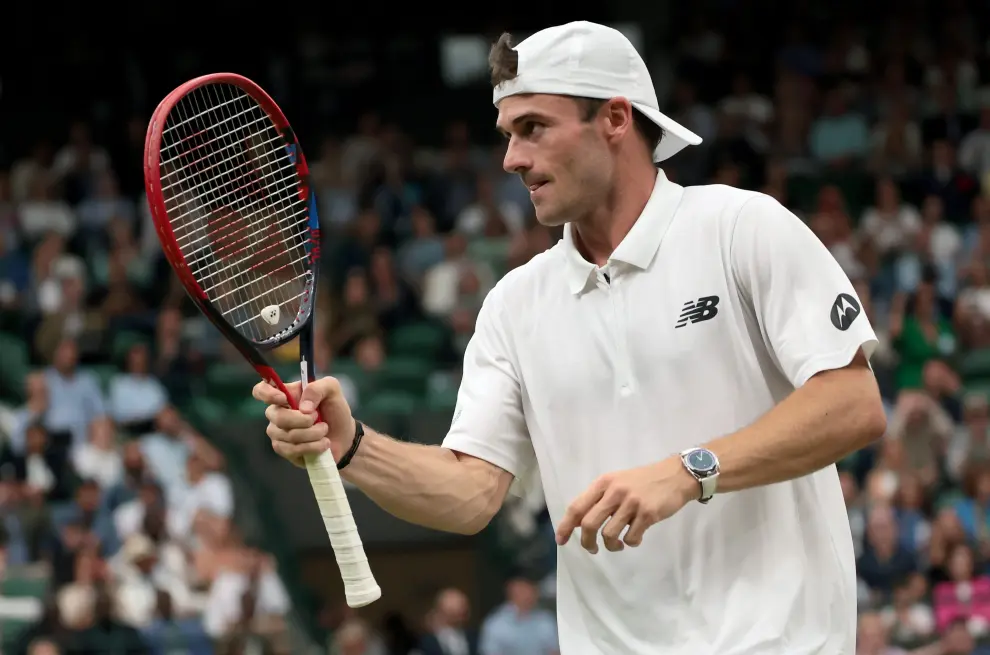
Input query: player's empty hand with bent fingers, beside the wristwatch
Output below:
<box><xmin>557</xmin><ymin>457</ymin><xmax>701</xmax><ymax>554</ymax></box>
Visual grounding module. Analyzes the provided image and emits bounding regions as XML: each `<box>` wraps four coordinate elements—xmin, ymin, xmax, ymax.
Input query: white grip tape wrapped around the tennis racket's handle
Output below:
<box><xmin>302</xmin><ymin>373</ymin><xmax>382</xmax><ymax>607</ymax></box>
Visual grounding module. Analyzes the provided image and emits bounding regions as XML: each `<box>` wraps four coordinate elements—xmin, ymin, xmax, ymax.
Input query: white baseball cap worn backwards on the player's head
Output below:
<box><xmin>493</xmin><ymin>21</ymin><xmax>701</xmax><ymax>162</ymax></box>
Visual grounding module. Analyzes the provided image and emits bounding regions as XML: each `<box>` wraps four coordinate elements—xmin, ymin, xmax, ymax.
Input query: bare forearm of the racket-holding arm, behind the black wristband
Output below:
<box><xmin>341</xmin><ymin>427</ymin><xmax>504</xmax><ymax>534</ymax></box>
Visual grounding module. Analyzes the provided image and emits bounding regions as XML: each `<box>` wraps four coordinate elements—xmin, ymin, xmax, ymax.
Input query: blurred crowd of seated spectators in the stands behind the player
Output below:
<box><xmin>0</xmin><ymin>0</ymin><xmax>990</xmax><ymax>655</ymax></box>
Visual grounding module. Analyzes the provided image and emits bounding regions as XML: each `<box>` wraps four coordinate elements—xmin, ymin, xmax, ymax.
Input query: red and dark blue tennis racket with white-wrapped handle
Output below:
<box><xmin>144</xmin><ymin>73</ymin><xmax>381</xmax><ymax>607</ymax></box>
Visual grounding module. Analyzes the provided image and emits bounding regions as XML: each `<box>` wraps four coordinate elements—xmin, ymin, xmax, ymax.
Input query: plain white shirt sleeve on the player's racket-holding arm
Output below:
<box><xmin>443</xmin><ymin>286</ymin><xmax>535</xmax><ymax>479</ymax></box>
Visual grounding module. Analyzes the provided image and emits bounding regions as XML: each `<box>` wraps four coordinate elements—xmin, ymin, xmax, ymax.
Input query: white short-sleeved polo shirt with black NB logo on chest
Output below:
<box><xmin>444</xmin><ymin>172</ymin><xmax>876</xmax><ymax>655</ymax></box>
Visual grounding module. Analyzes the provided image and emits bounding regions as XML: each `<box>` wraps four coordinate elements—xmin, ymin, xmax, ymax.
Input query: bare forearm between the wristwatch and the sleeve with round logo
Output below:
<box><xmin>707</xmin><ymin>358</ymin><xmax>886</xmax><ymax>492</ymax></box>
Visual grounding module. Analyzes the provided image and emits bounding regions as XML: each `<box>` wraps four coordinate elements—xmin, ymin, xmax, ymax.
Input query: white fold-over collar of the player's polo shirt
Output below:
<box><xmin>563</xmin><ymin>170</ymin><xmax>684</xmax><ymax>294</ymax></box>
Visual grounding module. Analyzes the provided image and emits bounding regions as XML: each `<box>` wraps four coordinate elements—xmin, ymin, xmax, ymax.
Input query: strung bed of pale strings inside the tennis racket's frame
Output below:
<box><xmin>160</xmin><ymin>84</ymin><xmax>312</xmax><ymax>342</ymax></box>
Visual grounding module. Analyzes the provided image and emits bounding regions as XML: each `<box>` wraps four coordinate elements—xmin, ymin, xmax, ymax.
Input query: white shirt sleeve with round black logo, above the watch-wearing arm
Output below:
<box><xmin>730</xmin><ymin>195</ymin><xmax>877</xmax><ymax>388</ymax></box>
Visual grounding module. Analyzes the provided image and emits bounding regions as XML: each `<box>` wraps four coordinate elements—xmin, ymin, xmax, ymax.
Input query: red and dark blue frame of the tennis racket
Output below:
<box><xmin>144</xmin><ymin>73</ymin><xmax>322</xmax><ymax>420</ymax></box>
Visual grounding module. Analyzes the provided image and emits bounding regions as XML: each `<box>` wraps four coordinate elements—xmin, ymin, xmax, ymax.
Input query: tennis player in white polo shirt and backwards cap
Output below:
<box><xmin>254</xmin><ymin>22</ymin><xmax>885</xmax><ymax>655</ymax></box>
